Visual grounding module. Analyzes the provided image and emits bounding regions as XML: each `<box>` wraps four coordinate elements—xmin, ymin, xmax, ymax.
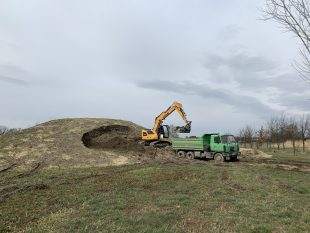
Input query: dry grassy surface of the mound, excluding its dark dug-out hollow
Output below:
<box><xmin>0</xmin><ymin>118</ymin><xmax>141</xmax><ymax>169</ymax></box>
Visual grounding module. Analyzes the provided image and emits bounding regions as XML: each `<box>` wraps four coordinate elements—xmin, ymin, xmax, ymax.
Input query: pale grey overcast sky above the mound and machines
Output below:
<box><xmin>0</xmin><ymin>0</ymin><xmax>310</xmax><ymax>134</ymax></box>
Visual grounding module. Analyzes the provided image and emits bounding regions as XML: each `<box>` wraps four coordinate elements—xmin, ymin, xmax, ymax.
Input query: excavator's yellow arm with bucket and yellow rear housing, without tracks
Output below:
<box><xmin>142</xmin><ymin>101</ymin><xmax>191</xmax><ymax>141</ymax></box>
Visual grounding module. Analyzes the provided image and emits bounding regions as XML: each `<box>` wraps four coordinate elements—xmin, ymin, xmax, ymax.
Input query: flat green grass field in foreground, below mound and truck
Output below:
<box><xmin>0</xmin><ymin>162</ymin><xmax>310</xmax><ymax>232</ymax></box>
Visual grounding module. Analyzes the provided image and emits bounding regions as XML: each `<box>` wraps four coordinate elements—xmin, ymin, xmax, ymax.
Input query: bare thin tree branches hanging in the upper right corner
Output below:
<box><xmin>264</xmin><ymin>0</ymin><xmax>310</xmax><ymax>82</ymax></box>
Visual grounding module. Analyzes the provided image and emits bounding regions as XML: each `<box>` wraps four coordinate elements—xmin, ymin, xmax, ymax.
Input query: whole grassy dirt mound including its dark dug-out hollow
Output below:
<box><xmin>0</xmin><ymin>118</ymin><xmax>142</xmax><ymax>170</ymax></box>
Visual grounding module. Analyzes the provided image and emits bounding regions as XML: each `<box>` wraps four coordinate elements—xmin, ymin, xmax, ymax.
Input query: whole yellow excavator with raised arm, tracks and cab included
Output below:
<box><xmin>142</xmin><ymin>101</ymin><xmax>192</xmax><ymax>147</ymax></box>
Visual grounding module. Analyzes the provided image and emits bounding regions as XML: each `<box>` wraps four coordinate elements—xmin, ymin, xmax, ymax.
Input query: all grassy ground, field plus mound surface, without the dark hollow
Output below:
<box><xmin>0</xmin><ymin>119</ymin><xmax>310</xmax><ymax>233</ymax></box>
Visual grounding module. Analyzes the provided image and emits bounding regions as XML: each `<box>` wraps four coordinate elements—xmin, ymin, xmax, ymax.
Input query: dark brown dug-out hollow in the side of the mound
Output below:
<box><xmin>82</xmin><ymin>125</ymin><xmax>142</xmax><ymax>150</ymax></box>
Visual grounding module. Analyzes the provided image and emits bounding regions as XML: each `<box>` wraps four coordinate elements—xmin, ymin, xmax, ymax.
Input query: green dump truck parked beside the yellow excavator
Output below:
<box><xmin>172</xmin><ymin>133</ymin><xmax>239</xmax><ymax>162</ymax></box>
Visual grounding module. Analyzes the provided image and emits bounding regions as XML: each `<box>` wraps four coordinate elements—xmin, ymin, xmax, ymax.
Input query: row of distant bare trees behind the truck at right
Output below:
<box><xmin>238</xmin><ymin>114</ymin><xmax>310</xmax><ymax>154</ymax></box>
